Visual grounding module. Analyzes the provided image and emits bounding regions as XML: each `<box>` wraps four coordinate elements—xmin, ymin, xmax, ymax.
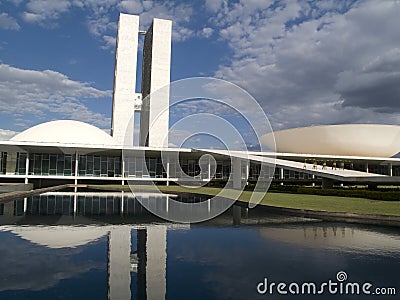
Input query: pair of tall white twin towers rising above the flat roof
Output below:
<box><xmin>111</xmin><ymin>13</ymin><xmax>172</xmax><ymax>147</ymax></box>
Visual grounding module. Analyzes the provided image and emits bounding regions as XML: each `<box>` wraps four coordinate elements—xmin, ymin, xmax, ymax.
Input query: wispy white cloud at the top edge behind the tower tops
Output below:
<box><xmin>15</xmin><ymin>0</ymin><xmax>195</xmax><ymax>50</ymax></box>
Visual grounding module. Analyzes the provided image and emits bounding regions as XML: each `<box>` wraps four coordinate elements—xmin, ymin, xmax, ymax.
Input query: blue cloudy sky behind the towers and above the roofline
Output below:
<box><xmin>0</xmin><ymin>0</ymin><xmax>400</xmax><ymax>144</ymax></box>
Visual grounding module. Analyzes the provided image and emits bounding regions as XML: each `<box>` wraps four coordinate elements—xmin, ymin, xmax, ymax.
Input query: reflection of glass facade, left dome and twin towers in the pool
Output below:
<box><xmin>0</xmin><ymin>193</ymin><xmax>190</xmax><ymax>300</ymax></box>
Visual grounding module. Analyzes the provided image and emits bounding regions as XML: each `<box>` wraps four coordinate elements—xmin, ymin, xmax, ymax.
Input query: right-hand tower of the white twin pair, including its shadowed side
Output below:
<box><xmin>140</xmin><ymin>19</ymin><xmax>172</xmax><ymax>147</ymax></box>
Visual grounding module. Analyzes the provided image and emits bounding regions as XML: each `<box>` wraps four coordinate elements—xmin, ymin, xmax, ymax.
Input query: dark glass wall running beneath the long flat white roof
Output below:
<box><xmin>0</xmin><ymin>152</ymin><xmax>400</xmax><ymax>181</ymax></box>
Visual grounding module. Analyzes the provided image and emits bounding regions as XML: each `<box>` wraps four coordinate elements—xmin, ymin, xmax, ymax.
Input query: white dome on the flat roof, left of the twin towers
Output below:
<box><xmin>11</xmin><ymin>120</ymin><xmax>115</xmax><ymax>145</ymax></box>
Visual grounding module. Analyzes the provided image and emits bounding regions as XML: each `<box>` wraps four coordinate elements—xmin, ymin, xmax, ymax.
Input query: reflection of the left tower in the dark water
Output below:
<box><xmin>108</xmin><ymin>226</ymin><xmax>131</xmax><ymax>300</ymax></box>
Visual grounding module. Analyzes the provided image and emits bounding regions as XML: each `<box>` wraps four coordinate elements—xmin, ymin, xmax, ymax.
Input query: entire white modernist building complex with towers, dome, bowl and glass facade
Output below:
<box><xmin>0</xmin><ymin>14</ymin><xmax>400</xmax><ymax>190</ymax></box>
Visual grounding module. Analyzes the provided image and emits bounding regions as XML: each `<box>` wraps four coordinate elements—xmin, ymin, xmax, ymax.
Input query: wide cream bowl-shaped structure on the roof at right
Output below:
<box><xmin>261</xmin><ymin>124</ymin><xmax>400</xmax><ymax>157</ymax></box>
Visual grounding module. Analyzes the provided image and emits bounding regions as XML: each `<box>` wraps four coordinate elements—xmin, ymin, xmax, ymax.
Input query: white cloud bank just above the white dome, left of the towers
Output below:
<box><xmin>0</xmin><ymin>64</ymin><xmax>111</xmax><ymax>127</ymax></box>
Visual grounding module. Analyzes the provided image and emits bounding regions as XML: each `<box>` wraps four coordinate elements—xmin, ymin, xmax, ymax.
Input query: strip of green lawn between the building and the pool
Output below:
<box><xmin>87</xmin><ymin>186</ymin><xmax>400</xmax><ymax>216</ymax></box>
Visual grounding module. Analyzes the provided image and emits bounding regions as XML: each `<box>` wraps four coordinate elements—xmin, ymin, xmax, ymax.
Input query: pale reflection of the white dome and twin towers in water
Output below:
<box><xmin>0</xmin><ymin>225</ymin><xmax>170</xmax><ymax>300</ymax></box>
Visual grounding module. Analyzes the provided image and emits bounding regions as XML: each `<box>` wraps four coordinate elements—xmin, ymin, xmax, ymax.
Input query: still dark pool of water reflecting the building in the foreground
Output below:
<box><xmin>0</xmin><ymin>193</ymin><xmax>400</xmax><ymax>300</ymax></box>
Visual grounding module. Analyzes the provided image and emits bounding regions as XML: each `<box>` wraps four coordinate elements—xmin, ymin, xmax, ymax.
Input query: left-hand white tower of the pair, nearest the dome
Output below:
<box><xmin>111</xmin><ymin>13</ymin><xmax>139</xmax><ymax>146</ymax></box>
